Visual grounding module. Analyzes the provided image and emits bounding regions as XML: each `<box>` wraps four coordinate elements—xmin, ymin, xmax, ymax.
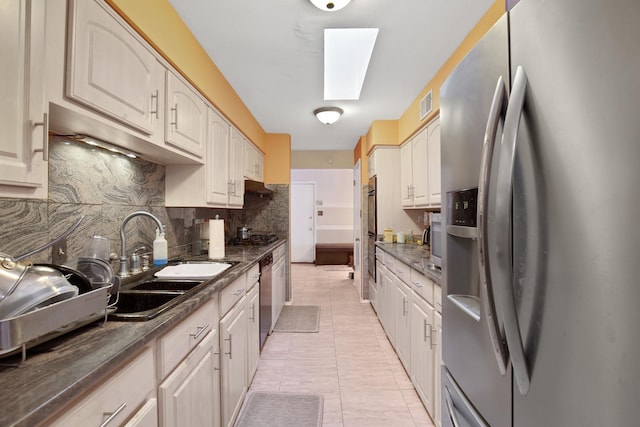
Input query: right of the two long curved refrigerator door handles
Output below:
<box><xmin>496</xmin><ymin>66</ymin><xmax>530</xmax><ymax>396</ymax></box>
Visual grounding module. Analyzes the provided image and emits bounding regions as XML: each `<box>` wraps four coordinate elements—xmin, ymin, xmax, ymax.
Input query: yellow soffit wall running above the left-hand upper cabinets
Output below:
<box><xmin>107</xmin><ymin>0</ymin><xmax>291</xmax><ymax>184</ymax></box>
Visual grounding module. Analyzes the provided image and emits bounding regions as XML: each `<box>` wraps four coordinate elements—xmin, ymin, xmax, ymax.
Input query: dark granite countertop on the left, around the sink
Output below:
<box><xmin>0</xmin><ymin>240</ymin><xmax>285</xmax><ymax>426</ymax></box>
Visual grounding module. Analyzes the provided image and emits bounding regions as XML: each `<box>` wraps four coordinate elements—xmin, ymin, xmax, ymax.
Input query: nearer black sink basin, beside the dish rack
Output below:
<box><xmin>109</xmin><ymin>291</ymin><xmax>188</xmax><ymax>321</ymax></box>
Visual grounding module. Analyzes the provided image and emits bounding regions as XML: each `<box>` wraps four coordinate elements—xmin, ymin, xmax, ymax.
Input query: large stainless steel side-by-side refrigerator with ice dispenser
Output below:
<box><xmin>440</xmin><ymin>0</ymin><xmax>640</xmax><ymax>427</ymax></box>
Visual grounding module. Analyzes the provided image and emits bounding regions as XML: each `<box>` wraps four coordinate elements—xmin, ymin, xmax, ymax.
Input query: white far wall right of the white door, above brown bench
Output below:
<box><xmin>291</xmin><ymin>169</ymin><xmax>353</xmax><ymax>243</ymax></box>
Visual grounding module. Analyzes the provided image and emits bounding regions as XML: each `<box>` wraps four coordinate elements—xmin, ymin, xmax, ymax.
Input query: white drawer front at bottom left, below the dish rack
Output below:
<box><xmin>51</xmin><ymin>348</ymin><xmax>155</xmax><ymax>427</ymax></box>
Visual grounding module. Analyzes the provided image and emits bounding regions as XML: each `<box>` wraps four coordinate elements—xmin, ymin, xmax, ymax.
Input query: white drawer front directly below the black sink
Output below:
<box><xmin>158</xmin><ymin>295</ymin><xmax>220</xmax><ymax>378</ymax></box>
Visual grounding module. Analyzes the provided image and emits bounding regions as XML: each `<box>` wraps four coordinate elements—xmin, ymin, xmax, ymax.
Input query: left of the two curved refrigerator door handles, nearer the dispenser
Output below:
<box><xmin>476</xmin><ymin>76</ymin><xmax>509</xmax><ymax>375</ymax></box>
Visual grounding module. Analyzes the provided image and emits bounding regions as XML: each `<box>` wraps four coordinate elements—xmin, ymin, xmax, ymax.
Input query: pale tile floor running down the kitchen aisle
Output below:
<box><xmin>249</xmin><ymin>264</ymin><xmax>433</xmax><ymax>427</ymax></box>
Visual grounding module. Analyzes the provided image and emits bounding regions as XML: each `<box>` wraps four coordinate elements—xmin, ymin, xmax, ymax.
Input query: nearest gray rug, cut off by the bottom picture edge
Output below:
<box><xmin>235</xmin><ymin>391</ymin><xmax>324</xmax><ymax>427</ymax></box>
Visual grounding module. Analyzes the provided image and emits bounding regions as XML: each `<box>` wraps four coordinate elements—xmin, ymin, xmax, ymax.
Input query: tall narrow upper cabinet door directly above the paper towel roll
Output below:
<box><xmin>205</xmin><ymin>109</ymin><xmax>229</xmax><ymax>205</ymax></box>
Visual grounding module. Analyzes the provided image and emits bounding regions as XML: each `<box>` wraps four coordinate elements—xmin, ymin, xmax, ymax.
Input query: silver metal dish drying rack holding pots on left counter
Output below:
<box><xmin>0</xmin><ymin>284</ymin><xmax>111</xmax><ymax>364</ymax></box>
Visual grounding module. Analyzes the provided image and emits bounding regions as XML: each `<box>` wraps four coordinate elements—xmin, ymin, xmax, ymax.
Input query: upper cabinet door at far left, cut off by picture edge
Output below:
<box><xmin>0</xmin><ymin>0</ymin><xmax>48</xmax><ymax>198</ymax></box>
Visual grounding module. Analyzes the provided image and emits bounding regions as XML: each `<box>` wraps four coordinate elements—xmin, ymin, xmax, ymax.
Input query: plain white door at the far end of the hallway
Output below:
<box><xmin>291</xmin><ymin>182</ymin><xmax>316</xmax><ymax>262</ymax></box>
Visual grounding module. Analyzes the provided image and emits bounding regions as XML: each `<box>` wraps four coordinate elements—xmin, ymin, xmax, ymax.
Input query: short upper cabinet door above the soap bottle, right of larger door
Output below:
<box><xmin>165</xmin><ymin>70</ymin><xmax>207</xmax><ymax>157</ymax></box>
